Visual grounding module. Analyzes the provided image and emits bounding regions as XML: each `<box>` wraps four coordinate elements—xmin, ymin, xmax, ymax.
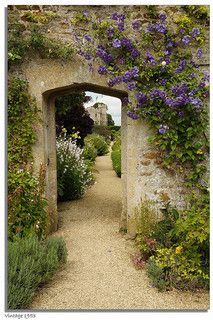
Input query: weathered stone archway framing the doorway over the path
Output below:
<box><xmin>21</xmin><ymin>59</ymin><xmax>140</xmax><ymax>232</ymax></box>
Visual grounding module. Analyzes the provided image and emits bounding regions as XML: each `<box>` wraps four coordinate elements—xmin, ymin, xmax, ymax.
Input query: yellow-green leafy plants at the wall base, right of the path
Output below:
<box><xmin>148</xmin><ymin>191</ymin><xmax>210</xmax><ymax>289</ymax></box>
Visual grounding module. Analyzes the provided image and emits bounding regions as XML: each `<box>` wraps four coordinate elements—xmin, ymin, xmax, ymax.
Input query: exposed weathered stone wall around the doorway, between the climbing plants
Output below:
<box><xmin>8</xmin><ymin>6</ymin><xmax>209</xmax><ymax>233</ymax></box>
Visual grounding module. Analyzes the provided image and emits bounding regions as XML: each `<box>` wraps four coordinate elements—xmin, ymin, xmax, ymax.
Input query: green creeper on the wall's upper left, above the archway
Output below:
<box><xmin>8</xmin><ymin>10</ymin><xmax>74</xmax><ymax>67</ymax></box>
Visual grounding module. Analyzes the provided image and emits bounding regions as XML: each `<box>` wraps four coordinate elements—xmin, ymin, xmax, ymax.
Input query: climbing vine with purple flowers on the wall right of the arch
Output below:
<box><xmin>75</xmin><ymin>6</ymin><xmax>209</xmax><ymax>186</ymax></box>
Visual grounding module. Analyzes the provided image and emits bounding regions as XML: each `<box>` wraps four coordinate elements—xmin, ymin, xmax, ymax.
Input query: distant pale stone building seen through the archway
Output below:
<box><xmin>87</xmin><ymin>102</ymin><xmax>108</xmax><ymax>126</ymax></box>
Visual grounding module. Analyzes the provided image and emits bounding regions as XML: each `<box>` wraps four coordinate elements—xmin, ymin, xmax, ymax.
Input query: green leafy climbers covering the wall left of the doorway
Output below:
<box><xmin>8</xmin><ymin>78</ymin><xmax>47</xmax><ymax>240</ymax></box>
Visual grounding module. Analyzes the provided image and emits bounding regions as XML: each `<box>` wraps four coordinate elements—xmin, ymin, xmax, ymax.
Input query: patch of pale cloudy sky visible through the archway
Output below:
<box><xmin>84</xmin><ymin>91</ymin><xmax>121</xmax><ymax>126</ymax></box>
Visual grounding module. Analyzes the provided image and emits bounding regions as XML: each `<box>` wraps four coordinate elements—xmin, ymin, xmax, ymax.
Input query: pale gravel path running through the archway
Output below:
<box><xmin>31</xmin><ymin>155</ymin><xmax>209</xmax><ymax>310</ymax></box>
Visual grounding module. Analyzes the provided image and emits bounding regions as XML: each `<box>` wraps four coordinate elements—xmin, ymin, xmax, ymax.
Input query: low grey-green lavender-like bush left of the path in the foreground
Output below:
<box><xmin>7</xmin><ymin>236</ymin><xmax>67</xmax><ymax>310</ymax></box>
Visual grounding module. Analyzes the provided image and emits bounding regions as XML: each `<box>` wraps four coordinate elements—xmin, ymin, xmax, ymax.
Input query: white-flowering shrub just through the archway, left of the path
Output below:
<box><xmin>56</xmin><ymin>137</ymin><xmax>93</xmax><ymax>201</ymax></box>
